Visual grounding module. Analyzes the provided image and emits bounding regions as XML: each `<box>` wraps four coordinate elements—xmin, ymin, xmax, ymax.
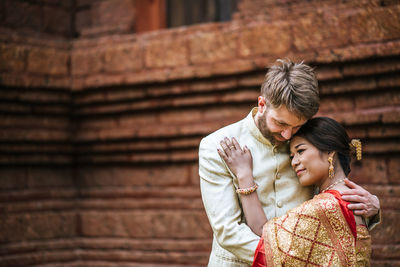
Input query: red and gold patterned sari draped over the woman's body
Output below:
<box><xmin>253</xmin><ymin>190</ymin><xmax>371</xmax><ymax>267</ymax></box>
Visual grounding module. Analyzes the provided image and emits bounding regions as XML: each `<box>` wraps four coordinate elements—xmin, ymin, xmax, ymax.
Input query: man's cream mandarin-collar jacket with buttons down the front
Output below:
<box><xmin>199</xmin><ymin>108</ymin><xmax>313</xmax><ymax>267</ymax></box>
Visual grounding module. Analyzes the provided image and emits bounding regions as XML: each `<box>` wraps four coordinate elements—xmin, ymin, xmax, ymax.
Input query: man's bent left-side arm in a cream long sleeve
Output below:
<box><xmin>199</xmin><ymin>139</ymin><xmax>259</xmax><ymax>264</ymax></box>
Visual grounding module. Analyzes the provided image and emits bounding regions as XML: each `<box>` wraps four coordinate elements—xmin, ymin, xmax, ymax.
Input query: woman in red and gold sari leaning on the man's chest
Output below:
<box><xmin>218</xmin><ymin>117</ymin><xmax>371</xmax><ymax>267</ymax></box>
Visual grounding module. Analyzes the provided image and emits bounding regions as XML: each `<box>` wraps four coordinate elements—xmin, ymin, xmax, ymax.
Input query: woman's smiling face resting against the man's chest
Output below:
<box><xmin>290</xmin><ymin>136</ymin><xmax>329</xmax><ymax>186</ymax></box>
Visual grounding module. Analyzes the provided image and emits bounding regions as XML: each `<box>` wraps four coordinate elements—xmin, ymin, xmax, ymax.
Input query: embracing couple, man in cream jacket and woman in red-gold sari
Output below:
<box><xmin>199</xmin><ymin>60</ymin><xmax>380</xmax><ymax>267</ymax></box>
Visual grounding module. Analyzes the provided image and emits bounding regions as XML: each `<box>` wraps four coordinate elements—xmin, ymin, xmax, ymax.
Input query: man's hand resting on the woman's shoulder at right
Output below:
<box><xmin>342</xmin><ymin>179</ymin><xmax>380</xmax><ymax>218</ymax></box>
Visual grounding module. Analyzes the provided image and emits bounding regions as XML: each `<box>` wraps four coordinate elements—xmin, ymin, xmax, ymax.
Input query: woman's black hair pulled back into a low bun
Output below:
<box><xmin>294</xmin><ymin>117</ymin><xmax>351</xmax><ymax>176</ymax></box>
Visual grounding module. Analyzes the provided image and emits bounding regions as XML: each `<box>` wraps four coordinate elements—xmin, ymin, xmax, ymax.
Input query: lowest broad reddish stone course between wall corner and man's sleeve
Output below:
<box><xmin>81</xmin><ymin>211</ymin><xmax>210</xmax><ymax>238</ymax></box>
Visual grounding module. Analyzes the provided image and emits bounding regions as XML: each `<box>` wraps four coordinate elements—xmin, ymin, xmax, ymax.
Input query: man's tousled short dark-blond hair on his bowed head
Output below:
<box><xmin>261</xmin><ymin>59</ymin><xmax>319</xmax><ymax>119</ymax></box>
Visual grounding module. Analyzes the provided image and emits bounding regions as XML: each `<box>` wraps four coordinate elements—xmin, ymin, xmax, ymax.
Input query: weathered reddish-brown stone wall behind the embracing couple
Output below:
<box><xmin>0</xmin><ymin>0</ymin><xmax>400</xmax><ymax>266</ymax></box>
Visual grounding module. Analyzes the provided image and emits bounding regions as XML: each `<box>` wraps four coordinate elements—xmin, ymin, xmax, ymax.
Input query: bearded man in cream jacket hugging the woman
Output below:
<box><xmin>199</xmin><ymin>60</ymin><xmax>379</xmax><ymax>267</ymax></box>
